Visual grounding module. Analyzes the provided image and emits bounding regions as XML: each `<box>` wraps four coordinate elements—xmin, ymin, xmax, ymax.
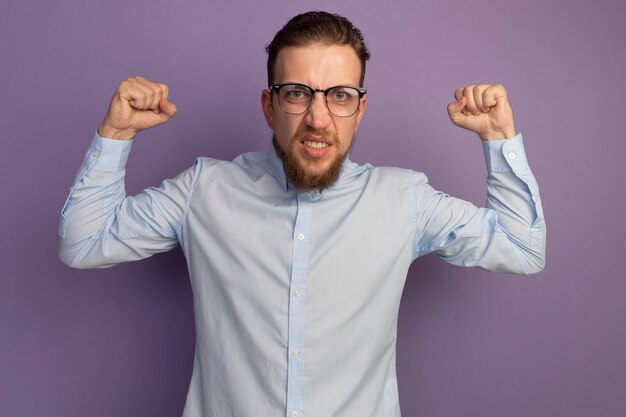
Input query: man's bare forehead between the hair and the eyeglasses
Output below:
<box><xmin>274</xmin><ymin>43</ymin><xmax>361</xmax><ymax>88</ymax></box>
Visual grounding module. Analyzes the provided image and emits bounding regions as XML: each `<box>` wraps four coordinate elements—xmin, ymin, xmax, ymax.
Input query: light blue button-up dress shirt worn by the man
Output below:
<box><xmin>59</xmin><ymin>134</ymin><xmax>545</xmax><ymax>417</ymax></box>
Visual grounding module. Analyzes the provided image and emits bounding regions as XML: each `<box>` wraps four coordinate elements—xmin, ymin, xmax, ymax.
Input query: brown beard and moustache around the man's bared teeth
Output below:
<box><xmin>272</xmin><ymin>127</ymin><xmax>354</xmax><ymax>191</ymax></box>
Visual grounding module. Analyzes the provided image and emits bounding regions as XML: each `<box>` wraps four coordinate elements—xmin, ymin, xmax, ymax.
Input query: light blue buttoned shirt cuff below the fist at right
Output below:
<box><xmin>483</xmin><ymin>133</ymin><xmax>528</xmax><ymax>172</ymax></box>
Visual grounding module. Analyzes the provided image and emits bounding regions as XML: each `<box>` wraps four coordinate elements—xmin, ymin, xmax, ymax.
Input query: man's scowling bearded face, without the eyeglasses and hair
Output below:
<box><xmin>261</xmin><ymin>43</ymin><xmax>366</xmax><ymax>190</ymax></box>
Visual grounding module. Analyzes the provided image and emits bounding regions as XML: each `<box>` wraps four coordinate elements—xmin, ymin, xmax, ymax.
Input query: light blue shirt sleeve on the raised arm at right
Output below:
<box><xmin>414</xmin><ymin>134</ymin><xmax>546</xmax><ymax>275</ymax></box>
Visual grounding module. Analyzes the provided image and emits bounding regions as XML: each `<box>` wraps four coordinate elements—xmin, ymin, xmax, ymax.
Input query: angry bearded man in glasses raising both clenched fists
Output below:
<box><xmin>60</xmin><ymin>12</ymin><xmax>545</xmax><ymax>417</ymax></box>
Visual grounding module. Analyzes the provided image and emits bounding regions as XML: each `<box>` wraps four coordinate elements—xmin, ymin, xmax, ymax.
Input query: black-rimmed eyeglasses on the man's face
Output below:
<box><xmin>269</xmin><ymin>83</ymin><xmax>367</xmax><ymax>117</ymax></box>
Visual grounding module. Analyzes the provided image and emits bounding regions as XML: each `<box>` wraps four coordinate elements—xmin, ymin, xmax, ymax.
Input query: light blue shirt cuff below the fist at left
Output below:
<box><xmin>85</xmin><ymin>130</ymin><xmax>133</xmax><ymax>172</ymax></box>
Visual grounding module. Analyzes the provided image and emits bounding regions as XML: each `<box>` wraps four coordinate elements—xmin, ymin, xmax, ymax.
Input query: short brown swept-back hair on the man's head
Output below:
<box><xmin>265</xmin><ymin>11</ymin><xmax>370</xmax><ymax>87</ymax></box>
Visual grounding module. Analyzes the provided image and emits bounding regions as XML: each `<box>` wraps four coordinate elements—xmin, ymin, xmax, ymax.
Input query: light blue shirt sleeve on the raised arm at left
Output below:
<box><xmin>59</xmin><ymin>132</ymin><xmax>197</xmax><ymax>268</ymax></box>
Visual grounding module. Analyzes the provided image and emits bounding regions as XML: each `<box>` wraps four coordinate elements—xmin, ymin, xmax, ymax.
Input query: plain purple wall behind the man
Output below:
<box><xmin>0</xmin><ymin>0</ymin><xmax>626</xmax><ymax>417</ymax></box>
